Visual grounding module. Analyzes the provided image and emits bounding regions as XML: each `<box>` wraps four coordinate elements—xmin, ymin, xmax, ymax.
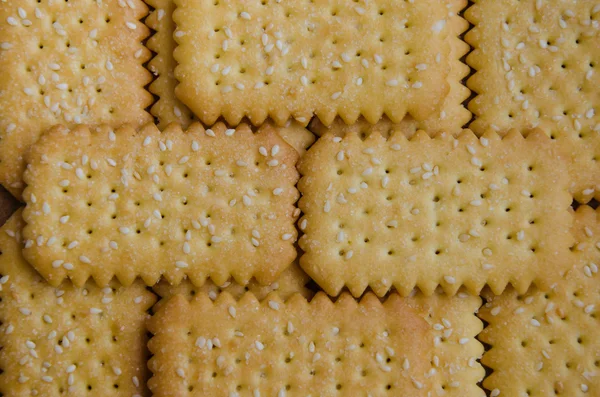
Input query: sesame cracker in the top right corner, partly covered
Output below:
<box><xmin>465</xmin><ymin>0</ymin><xmax>600</xmax><ymax>202</ymax></box>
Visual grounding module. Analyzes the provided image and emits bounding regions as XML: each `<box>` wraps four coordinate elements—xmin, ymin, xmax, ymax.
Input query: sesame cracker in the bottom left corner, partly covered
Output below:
<box><xmin>0</xmin><ymin>210</ymin><xmax>156</xmax><ymax>396</ymax></box>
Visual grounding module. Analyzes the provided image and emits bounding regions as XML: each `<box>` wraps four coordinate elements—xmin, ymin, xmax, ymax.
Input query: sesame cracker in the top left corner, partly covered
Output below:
<box><xmin>0</xmin><ymin>0</ymin><xmax>152</xmax><ymax>197</ymax></box>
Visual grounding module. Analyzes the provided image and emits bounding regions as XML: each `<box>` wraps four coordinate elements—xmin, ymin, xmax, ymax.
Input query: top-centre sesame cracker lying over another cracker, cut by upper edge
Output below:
<box><xmin>173</xmin><ymin>0</ymin><xmax>451</xmax><ymax>125</ymax></box>
